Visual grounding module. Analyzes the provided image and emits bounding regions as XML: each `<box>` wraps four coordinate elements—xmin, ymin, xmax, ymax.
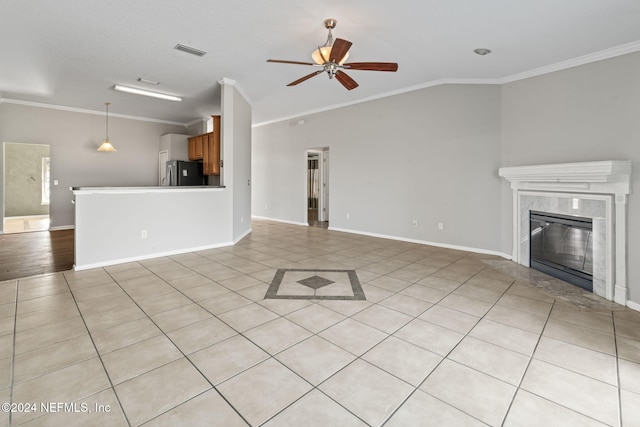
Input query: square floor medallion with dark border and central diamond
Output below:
<box><xmin>264</xmin><ymin>268</ymin><xmax>366</xmax><ymax>301</ymax></box>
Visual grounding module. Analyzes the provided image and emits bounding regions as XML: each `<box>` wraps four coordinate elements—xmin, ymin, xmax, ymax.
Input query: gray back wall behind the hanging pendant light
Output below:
<box><xmin>0</xmin><ymin>103</ymin><xmax>185</xmax><ymax>229</ymax></box>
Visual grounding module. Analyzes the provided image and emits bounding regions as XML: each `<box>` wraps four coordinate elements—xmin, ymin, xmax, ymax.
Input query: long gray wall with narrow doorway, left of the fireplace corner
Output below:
<box><xmin>252</xmin><ymin>85</ymin><xmax>502</xmax><ymax>252</ymax></box>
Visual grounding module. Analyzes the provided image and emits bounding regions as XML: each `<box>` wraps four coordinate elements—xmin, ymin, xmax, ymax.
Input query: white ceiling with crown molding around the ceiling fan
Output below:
<box><xmin>0</xmin><ymin>0</ymin><xmax>640</xmax><ymax>123</ymax></box>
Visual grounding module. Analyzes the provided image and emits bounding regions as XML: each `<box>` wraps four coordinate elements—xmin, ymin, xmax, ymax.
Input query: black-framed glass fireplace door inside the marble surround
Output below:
<box><xmin>529</xmin><ymin>211</ymin><xmax>593</xmax><ymax>291</ymax></box>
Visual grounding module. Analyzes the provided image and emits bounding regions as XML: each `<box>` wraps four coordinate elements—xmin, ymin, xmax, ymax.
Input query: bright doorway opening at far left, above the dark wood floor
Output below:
<box><xmin>3</xmin><ymin>142</ymin><xmax>51</xmax><ymax>233</ymax></box>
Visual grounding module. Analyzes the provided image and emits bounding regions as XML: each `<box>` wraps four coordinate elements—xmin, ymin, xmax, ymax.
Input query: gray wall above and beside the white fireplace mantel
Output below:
<box><xmin>502</xmin><ymin>53</ymin><xmax>640</xmax><ymax>303</ymax></box>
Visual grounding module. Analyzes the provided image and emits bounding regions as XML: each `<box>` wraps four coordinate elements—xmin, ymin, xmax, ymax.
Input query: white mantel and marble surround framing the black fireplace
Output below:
<box><xmin>498</xmin><ymin>160</ymin><xmax>631</xmax><ymax>305</ymax></box>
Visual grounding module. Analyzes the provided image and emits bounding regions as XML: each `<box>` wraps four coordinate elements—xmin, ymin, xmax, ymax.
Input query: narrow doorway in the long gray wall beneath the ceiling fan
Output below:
<box><xmin>307</xmin><ymin>147</ymin><xmax>329</xmax><ymax>228</ymax></box>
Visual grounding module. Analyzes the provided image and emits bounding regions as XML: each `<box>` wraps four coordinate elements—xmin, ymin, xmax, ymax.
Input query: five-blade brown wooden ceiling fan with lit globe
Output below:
<box><xmin>267</xmin><ymin>18</ymin><xmax>398</xmax><ymax>90</ymax></box>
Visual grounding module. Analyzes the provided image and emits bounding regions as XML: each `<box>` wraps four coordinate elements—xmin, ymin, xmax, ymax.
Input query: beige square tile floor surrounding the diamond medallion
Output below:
<box><xmin>0</xmin><ymin>221</ymin><xmax>640</xmax><ymax>427</ymax></box>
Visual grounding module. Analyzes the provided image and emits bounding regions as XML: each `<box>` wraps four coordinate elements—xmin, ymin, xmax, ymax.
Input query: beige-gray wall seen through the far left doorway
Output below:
<box><xmin>4</xmin><ymin>143</ymin><xmax>49</xmax><ymax>216</ymax></box>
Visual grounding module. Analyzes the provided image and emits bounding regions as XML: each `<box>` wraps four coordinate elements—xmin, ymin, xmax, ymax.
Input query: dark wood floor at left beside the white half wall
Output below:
<box><xmin>0</xmin><ymin>230</ymin><xmax>74</xmax><ymax>281</ymax></box>
